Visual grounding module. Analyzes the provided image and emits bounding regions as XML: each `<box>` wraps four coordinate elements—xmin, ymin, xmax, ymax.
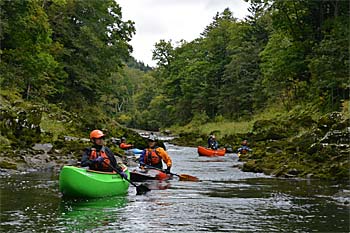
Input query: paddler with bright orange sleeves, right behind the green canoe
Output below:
<box><xmin>139</xmin><ymin>135</ymin><xmax>172</xmax><ymax>174</ymax></box>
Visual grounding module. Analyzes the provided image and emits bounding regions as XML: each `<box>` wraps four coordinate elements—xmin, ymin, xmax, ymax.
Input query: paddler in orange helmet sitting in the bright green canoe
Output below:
<box><xmin>81</xmin><ymin>129</ymin><xmax>127</xmax><ymax>178</ymax></box>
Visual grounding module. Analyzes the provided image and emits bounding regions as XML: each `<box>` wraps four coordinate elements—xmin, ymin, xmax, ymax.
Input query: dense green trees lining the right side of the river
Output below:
<box><xmin>127</xmin><ymin>0</ymin><xmax>350</xmax><ymax>128</ymax></box>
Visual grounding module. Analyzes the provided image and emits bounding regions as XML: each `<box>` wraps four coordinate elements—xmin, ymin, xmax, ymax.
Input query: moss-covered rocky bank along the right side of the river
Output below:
<box><xmin>173</xmin><ymin>112</ymin><xmax>350</xmax><ymax>181</ymax></box>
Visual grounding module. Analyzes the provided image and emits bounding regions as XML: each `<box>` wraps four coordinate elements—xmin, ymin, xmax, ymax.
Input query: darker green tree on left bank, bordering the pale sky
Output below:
<box><xmin>46</xmin><ymin>0</ymin><xmax>135</xmax><ymax>111</ymax></box>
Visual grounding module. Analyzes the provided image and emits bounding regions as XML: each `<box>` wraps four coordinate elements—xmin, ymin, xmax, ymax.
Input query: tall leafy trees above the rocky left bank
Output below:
<box><xmin>0</xmin><ymin>0</ymin><xmax>135</xmax><ymax>138</ymax></box>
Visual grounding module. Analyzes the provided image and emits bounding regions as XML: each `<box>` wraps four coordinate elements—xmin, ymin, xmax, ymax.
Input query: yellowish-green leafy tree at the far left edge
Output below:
<box><xmin>0</xmin><ymin>1</ymin><xmax>65</xmax><ymax>101</ymax></box>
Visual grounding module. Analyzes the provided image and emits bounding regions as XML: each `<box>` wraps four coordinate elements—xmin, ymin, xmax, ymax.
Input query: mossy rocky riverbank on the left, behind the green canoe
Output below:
<box><xmin>0</xmin><ymin>97</ymin><xmax>147</xmax><ymax>172</ymax></box>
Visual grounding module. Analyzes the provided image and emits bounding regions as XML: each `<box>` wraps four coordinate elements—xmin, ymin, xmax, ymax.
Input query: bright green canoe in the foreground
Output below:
<box><xmin>59</xmin><ymin>166</ymin><xmax>130</xmax><ymax>198</ymax></box>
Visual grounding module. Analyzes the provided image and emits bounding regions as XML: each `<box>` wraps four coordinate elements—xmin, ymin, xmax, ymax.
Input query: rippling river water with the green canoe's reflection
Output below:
<box><xmin>0</xmin><ymin>145</ymin><xmax>350</xmax><ymax>232</ymax></box>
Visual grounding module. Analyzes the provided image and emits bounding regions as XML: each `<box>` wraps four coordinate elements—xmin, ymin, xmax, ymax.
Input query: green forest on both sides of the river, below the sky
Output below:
<box><xmin>0</xmin><ymin>0</ymin><xmax>350</xmax><ymax>151</ymax></box>
